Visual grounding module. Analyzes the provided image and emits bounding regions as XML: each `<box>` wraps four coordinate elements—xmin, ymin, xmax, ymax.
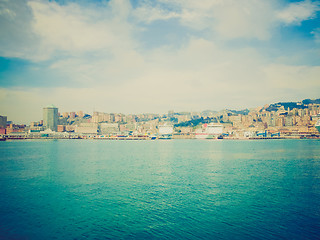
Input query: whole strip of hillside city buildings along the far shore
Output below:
<box><xmin>0</xmin><ymin>100</ymin><xmax>320</xmax><ymax>139</ymax></box>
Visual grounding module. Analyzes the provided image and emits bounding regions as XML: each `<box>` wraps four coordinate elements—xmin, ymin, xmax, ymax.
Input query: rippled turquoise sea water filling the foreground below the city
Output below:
<box><xmin>0</xmin><ymin>140</ymin><xmax>320</xmax><ymax>239</ymax></box>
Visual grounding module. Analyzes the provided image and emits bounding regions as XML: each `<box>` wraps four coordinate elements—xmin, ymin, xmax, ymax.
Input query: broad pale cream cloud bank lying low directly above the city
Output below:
<box><xmin>4</xmin><ymin>38</ymin><xmax>312</xmax><ymax>121</ymax></box>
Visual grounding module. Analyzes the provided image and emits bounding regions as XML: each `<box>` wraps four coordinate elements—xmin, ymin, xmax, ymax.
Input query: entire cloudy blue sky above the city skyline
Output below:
<box><xmin>0</xmin><ymin>0</ymin><xmax>320</xmax><ymax>124</ymax></box>
